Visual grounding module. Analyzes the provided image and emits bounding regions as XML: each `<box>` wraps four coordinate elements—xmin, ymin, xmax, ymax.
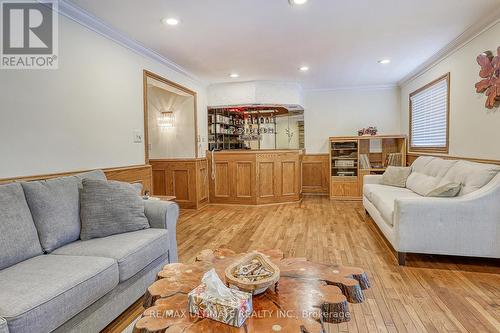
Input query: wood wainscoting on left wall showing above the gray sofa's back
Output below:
<box><xmin>0</xmin><ymin>164</ymin><xmax>152</xmax><ymax>191</ymax></box>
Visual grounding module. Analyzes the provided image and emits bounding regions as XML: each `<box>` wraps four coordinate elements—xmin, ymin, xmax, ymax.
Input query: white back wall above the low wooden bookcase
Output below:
<box><xmin>304</xmin><ymin>87</ymin><xmax>400</xmax><ymax>154</ymax></box>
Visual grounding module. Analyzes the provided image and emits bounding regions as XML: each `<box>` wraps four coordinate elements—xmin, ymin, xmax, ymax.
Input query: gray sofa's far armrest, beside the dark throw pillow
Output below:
<box><xmin>144</xmin><ymin>200</ymin><xmax>179</xmax><ymax>262</ymax></box>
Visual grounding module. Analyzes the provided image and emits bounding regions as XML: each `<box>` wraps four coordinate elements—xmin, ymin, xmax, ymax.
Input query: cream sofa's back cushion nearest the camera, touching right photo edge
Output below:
<box><xmin>440</xmin><ymin>160</ymin><xmax>500</xmax><ymax>196</ymax></box>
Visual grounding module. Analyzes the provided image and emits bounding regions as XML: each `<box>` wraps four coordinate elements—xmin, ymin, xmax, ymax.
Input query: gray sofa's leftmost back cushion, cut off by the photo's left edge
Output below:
<box><xmin>0</xmin><ymin>183</ymin><xmax>42</xmax><ymax>270</ymax></box>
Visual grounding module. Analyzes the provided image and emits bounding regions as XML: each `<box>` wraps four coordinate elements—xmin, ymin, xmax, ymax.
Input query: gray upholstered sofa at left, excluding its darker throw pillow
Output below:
<box><xmin>0</xmin><ymin>171</ymin><xmax>179</xmax><ymax>333</ymax></box>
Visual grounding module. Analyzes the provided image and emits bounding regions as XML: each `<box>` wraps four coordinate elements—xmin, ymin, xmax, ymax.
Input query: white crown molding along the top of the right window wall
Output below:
<box><xmin>398</xmin><ymin>8</ymin><xmax>500</xmax><ymax>86</ymax></box>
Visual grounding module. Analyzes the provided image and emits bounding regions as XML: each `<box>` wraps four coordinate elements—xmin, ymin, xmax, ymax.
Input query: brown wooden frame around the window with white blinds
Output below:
<box><xmin>408</xmin><ymin>72</ymin><xmax>450</xmax><ymax>154</ymax></box>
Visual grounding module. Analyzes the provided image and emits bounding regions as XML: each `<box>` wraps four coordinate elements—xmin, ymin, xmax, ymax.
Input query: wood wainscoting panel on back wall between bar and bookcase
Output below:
<box><xmin>302</xmin><ymin>154</ymin><xmax>330</xmax><ymax>195</ymax></box>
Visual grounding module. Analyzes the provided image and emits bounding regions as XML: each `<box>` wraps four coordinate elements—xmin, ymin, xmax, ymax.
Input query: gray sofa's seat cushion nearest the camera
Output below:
<box><xmin>0</xmin><ymin>255</ymin><xmax>118</xmax><ymax>333</ymax></box>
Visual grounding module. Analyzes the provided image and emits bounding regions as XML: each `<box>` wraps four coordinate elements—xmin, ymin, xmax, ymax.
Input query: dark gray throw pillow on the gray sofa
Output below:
<box><xmin>80</xmin><ymin>179</ymin><xmax>149</xmax><ymax>240</ymax></box>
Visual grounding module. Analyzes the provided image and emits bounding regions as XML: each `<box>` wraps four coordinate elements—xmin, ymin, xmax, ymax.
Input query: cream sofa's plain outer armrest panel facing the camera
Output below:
<box><xmin>394</xmin><ymin>188</ymin><xmax>500</xmax><ymax>258</ymax></box>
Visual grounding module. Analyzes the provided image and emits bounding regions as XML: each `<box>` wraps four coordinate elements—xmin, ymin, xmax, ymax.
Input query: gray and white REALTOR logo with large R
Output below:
<box><xmin>0</xmin><ymin>0</ymin><xmax>58</xmax><ymax>69</ymax></box>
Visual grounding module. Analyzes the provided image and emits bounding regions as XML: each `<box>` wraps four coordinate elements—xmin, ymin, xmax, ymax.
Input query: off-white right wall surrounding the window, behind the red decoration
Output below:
<box><xmin>401</xmin><ymin>22</ymin><xmax>500</xmax><ymax>160</ymax></box>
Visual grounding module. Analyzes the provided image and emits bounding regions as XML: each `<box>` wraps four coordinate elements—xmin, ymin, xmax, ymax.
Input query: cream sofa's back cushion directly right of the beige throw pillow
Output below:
<box><xmin>406</xmin><ymin>156</ymin><xmax>457</xmax><ymax>196</ymax></box>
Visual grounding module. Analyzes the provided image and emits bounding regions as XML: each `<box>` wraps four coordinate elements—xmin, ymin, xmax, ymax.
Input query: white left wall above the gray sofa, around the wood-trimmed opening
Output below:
<box><xmin>0</xmin><ymin>17</ymin><xmax>207</xmax><ymax>178</ymax></box>
